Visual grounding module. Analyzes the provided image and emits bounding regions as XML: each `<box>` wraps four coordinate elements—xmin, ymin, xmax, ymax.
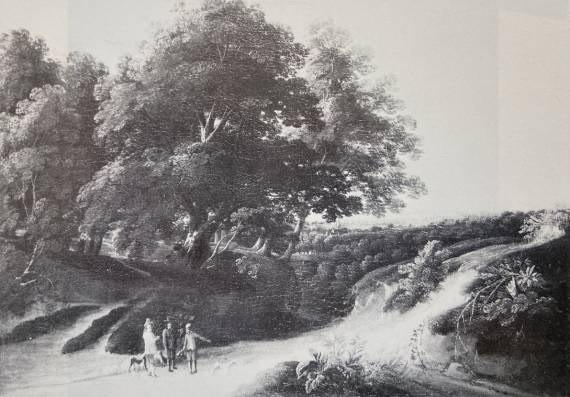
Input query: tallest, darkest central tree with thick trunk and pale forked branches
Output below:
<box><xmin>84</xmin><ymin>1</ymin><xmax>320</xmax><ymax>267</ymax></box>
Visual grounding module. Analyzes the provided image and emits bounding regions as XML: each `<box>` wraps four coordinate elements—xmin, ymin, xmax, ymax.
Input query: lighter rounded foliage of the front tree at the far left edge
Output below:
<box><xmin>0</xmin><ymin>86</ymin><xmax>90</xmax><ymax>248</ymax></box>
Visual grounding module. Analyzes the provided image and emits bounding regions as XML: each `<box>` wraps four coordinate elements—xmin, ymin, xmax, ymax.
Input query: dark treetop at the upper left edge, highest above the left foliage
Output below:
<box><xmin>0</xmin><ymin>29</ymin><xmax>60</xmax><ymax>113</ymax></box>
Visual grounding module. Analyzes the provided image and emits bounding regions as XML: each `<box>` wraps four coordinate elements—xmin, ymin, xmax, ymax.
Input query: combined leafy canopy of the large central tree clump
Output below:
<box><xmin>79</xmin><ymin>0</ymin><xmax>421</xmax><ymax>267</ymax></box>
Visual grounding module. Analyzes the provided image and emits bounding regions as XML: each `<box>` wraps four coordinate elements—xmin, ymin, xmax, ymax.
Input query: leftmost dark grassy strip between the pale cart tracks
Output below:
<box><xmin>2</xmin><ymin>305</ymin><xmax>100</xmax><ymax>343</ymax></box>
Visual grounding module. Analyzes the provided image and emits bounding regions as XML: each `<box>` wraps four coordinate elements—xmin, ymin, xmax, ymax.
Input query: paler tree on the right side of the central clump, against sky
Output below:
<box><xmin>278</xmin><ymin>24</ymin><xmax>425</xmax><ymax>256</ymax></box>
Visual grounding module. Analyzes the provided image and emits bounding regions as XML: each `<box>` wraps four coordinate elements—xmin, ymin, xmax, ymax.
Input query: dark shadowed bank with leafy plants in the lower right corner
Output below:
<box><xmin>432</xmin><ymin>237</ymin><xmax>570</xmax><ymax>395</ymax></box>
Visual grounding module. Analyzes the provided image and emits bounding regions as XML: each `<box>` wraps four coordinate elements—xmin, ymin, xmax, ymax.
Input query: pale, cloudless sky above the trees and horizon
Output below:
<box><xmin>0</xmin><ymin>0</ymin><xmax>570</xmax><ymax>226</ymax></box>
